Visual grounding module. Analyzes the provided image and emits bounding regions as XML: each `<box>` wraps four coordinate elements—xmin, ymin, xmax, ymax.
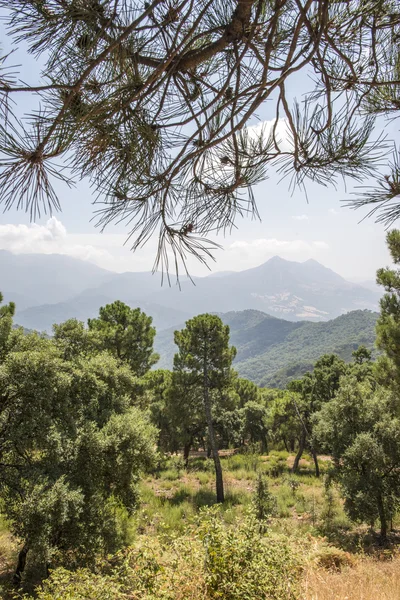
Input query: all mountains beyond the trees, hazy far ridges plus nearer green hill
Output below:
<box><xmin>0</xmin><ymin>250</ymin><xmax>380</xmax><ymax>387</ymax></box>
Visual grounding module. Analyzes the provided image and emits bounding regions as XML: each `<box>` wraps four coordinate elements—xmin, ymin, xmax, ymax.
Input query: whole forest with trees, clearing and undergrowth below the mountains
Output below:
<box><xmin>0</xmin><ymin>230</ymin><xmax>400</xmax><ymax>600</ymax></box>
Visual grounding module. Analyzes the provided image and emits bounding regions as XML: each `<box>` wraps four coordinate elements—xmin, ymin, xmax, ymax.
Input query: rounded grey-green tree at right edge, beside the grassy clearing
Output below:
<box><xmin>315</xmin><ymin>375</ymin><xmax>400</xmax><ymax>538</ymax></box>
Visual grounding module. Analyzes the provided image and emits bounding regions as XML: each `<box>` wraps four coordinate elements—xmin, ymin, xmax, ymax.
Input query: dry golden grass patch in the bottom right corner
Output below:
<box><xmin>302</xmin><ymin>556</ymin><xmax>400</xmax><ymax>600</ymax></box>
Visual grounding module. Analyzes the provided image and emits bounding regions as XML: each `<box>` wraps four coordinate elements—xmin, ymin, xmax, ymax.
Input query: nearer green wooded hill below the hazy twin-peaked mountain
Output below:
<box><xmin>155</xmin><ymin>310</ymin><xmax>378</xmax><ymax>387</ymax></box>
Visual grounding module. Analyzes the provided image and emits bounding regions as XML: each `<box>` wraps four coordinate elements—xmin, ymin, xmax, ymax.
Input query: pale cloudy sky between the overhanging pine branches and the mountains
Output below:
<box><xmin>0</xmin><ymin>14</ymin><xmax>398</xmax><ymax>281</ymax></box>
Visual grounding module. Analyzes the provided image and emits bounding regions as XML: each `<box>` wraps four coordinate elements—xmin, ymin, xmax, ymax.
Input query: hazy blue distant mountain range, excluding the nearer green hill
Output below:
<box><xmin>0</xmin><ymin>250</ymin><xmax>379</xmax><ymax>332</ymax></box>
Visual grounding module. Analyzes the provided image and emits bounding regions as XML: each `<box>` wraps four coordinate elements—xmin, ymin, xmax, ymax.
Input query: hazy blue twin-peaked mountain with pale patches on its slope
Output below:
<box><xmin>146</xmin><ymin>256</ymin><xmax>379</xmax><ymax>321</ymax></box>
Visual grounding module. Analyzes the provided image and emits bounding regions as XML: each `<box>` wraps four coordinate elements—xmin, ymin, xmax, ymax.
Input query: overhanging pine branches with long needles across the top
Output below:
<box><xmin>0</xmin><ymin>0</ymin><xmax>400</xmax><ymax>268</ymax></box>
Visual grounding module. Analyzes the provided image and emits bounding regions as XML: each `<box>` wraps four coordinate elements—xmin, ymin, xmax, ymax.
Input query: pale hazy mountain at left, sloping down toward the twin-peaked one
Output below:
<box><xmin>0</xmin><ymin>250</ymin><xmax>190</xmax><ymax>333</ymax></box>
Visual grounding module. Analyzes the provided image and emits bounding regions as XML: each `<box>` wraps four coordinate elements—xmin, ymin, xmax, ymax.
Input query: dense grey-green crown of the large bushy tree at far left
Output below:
<box><xmin>0</xmin><ymin>304</ymin><xmax>156</xmax><ymax>576</ymax></box>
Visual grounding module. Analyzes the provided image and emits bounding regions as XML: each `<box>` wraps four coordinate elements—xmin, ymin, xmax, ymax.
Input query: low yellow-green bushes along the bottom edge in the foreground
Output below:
<box><xmin>25</xmin><ymin>506</ymin><xmax>300</xmax><ymax>600</ymax></box>
